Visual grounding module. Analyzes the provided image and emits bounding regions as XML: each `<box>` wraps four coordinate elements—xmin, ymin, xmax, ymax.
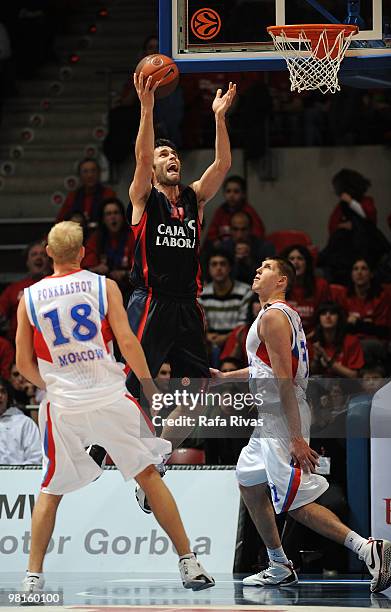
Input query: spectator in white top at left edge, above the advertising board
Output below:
<box><xmin>0</xmin><ymin>378</ymin><xmax>42</xmax><ymax>465</ymax></box>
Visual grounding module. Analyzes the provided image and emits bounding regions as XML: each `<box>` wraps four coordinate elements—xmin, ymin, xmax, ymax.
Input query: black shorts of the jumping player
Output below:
<box><xmin>127</xmin><ymin>289</ymin><xmax>210</xmax><ymax>397</ymax></box>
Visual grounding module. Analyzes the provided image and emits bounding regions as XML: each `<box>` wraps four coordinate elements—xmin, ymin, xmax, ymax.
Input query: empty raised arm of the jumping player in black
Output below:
<box><xmin>191</xmin><ymin>83</ymin><xmax>236</xmax><ymax>210</ymax></box>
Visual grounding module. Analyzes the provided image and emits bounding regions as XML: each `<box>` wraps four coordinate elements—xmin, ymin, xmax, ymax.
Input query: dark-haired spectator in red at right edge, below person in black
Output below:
<box><xmin>344</xmin><ymin>259</ymin><xmax>391</xmax><ymax>364</ymax></box>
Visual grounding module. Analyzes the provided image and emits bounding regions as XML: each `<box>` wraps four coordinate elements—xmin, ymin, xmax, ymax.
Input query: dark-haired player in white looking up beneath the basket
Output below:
<box><xmin>211</xmin><ymin>257</ymin><xmax>391</xmax><ymax>592</ymax></box>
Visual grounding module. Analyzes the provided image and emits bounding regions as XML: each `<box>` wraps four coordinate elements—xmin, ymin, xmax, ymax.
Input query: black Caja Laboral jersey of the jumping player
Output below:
<box><xmin>128</xmin><ymin>187</ymin><xmax>202</xmax><ymax>299</ymax></box>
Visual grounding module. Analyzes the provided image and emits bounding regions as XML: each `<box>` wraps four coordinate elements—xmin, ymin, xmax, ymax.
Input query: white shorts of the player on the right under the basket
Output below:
<box><xmin>236</xmin><ymin>401</ymin><xmax>329</xmax><ymax>514</ymax></box>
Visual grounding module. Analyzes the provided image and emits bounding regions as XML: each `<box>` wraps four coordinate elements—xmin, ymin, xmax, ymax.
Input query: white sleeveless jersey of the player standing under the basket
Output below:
<box><xmin>246</xmin><ymin>301</ymin><xmax>309</xmax><ymax>404</ymax></box>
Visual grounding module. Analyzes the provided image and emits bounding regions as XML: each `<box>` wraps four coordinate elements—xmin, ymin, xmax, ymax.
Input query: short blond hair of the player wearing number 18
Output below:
<box><xmin>48</xmin><ymin>221</ymin><xmax>83</xmax><ymax>263</ymax></box>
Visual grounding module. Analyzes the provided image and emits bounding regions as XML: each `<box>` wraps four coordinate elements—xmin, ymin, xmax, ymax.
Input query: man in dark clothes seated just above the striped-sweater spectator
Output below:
<box><xmin>223</xmin><ymin>211</ymin><xmax>275</xmax><ymax>285</ymax></box>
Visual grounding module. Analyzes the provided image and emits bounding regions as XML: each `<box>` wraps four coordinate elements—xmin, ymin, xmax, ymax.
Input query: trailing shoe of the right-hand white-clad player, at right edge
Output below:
<box><xmin>358</xmin><ymin>538</ymin><xmax>391</xmax><ymax>593</ymax></box>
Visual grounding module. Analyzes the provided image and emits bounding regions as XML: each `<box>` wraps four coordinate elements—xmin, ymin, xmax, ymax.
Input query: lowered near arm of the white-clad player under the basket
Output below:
<box><xmin>258</xmin><ymin>309</ymin><xmax>318</xmax><ymax>472</ymax></box>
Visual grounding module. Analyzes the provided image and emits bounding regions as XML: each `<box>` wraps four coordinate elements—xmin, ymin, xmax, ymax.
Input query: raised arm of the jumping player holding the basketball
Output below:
<box><xmin>129</xmin><ymin>72</ymin><xmax>160</xmax><ymax>223</ymax></box>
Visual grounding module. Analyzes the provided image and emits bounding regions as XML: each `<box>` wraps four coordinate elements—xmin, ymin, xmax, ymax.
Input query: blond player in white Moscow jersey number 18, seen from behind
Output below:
<box><xmin>16</xmin><ymin>221</ymin><xmax>214</xmax><ymax>591</ymax></box>
